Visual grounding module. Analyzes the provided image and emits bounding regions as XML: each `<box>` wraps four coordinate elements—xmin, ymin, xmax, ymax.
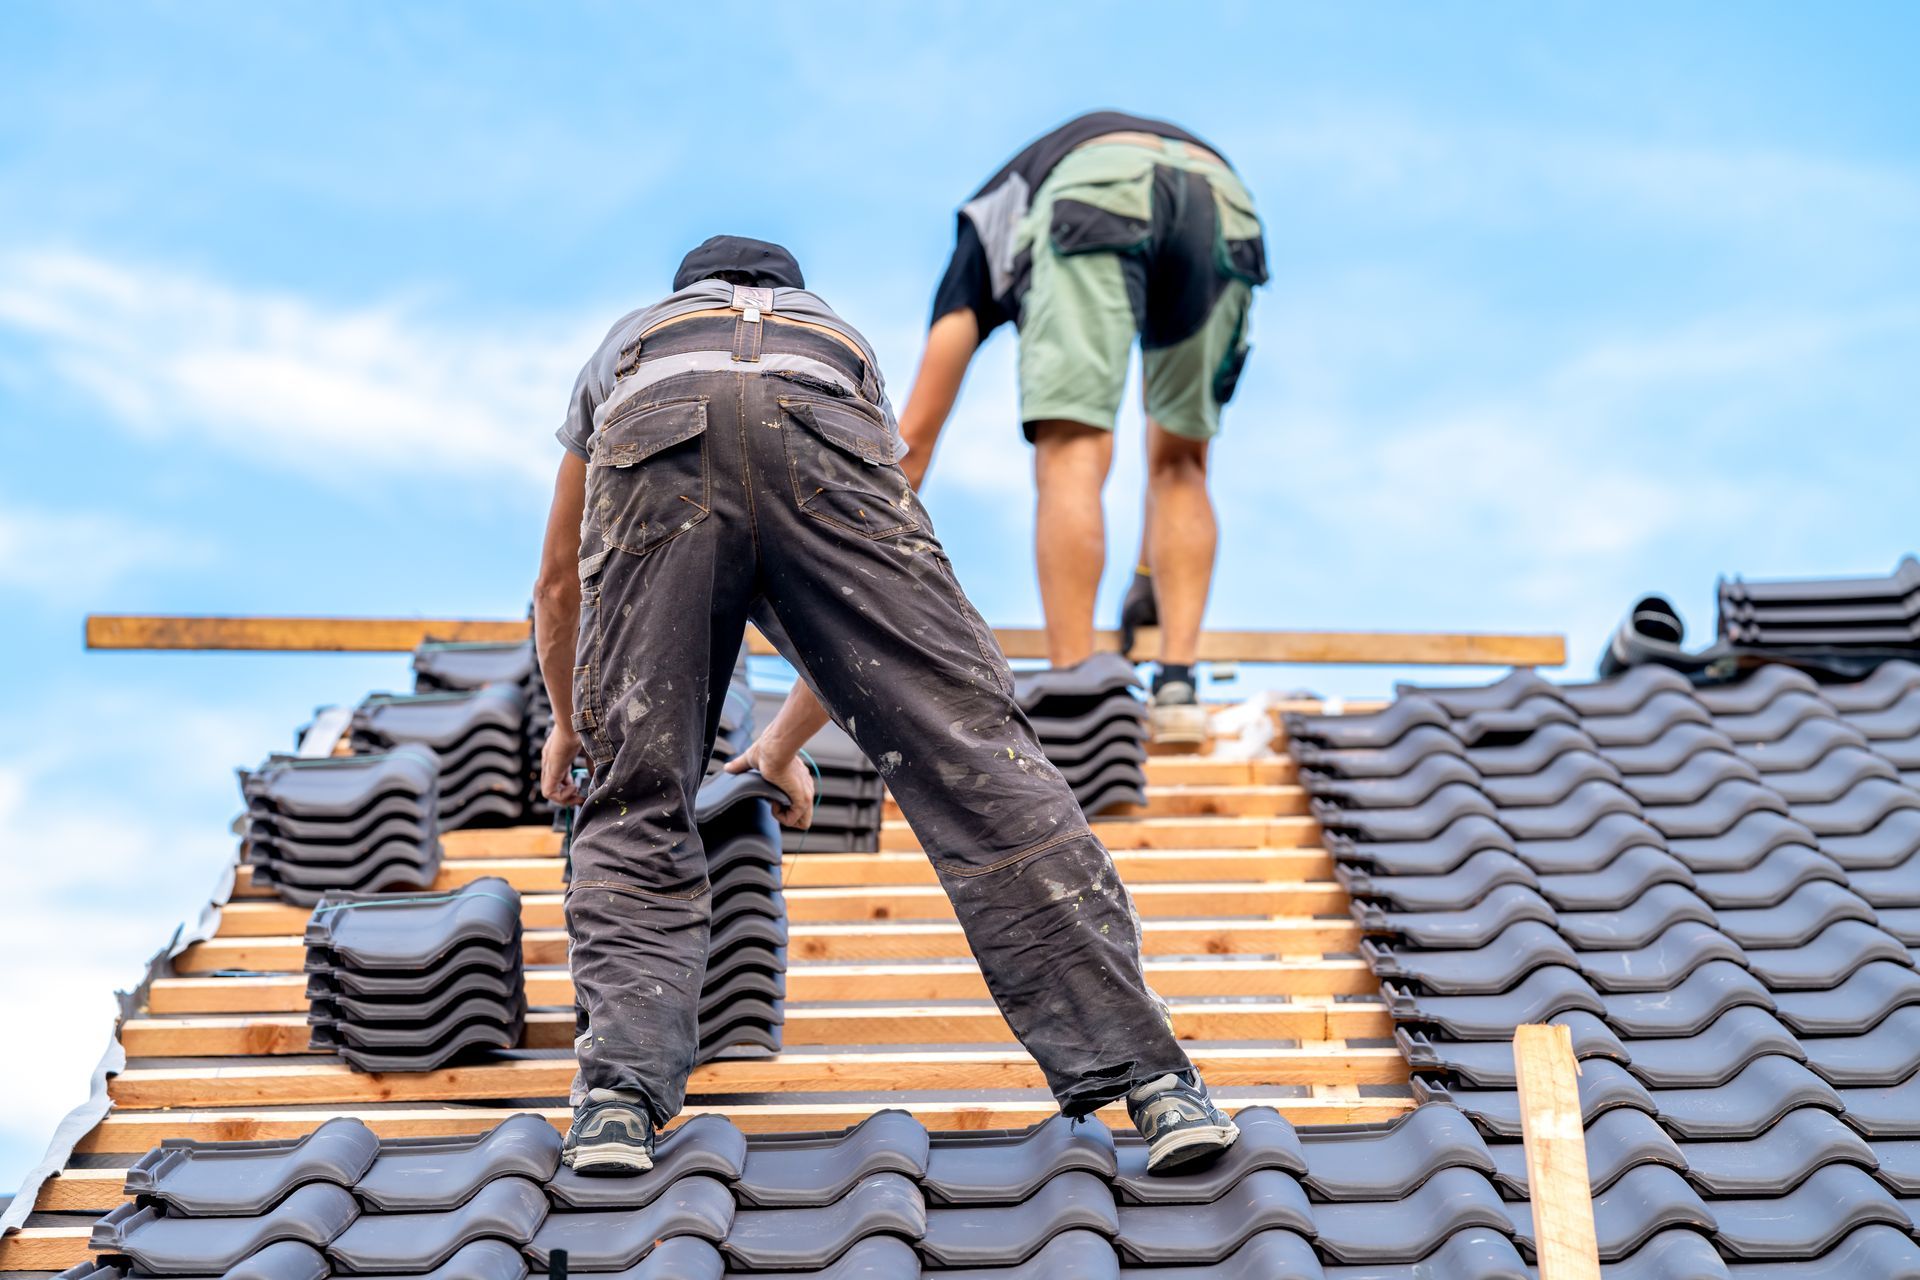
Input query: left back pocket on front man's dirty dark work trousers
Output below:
<box><xmin>588</xmin><ymin>395</ymin><xmax>712</xmax><ymax>555</ymax></box>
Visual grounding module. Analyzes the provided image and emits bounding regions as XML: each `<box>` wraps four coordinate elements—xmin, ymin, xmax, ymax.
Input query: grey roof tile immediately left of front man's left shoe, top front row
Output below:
<box><xmin>353</xmin><ymin>1113</ymin><xmax>561</xmax><ymax>1213</ymax></box>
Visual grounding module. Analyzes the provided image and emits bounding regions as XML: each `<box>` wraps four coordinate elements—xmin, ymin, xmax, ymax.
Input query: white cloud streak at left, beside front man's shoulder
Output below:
<box><xmin>0</xmin><ymin>249</ymin><xmax>599</xmax><ymax>482</ymax></box>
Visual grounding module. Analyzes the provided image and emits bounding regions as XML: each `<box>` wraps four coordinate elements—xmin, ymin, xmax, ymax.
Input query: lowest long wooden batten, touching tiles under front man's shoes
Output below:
<box><xmin>75</xmin><ymin>1088</ymin><xmax>1413</xmax><ymax>1155</ymax></box>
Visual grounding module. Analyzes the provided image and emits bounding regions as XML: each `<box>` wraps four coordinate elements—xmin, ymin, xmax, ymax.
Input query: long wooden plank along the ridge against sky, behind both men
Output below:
<box><xmin>86</xmin><ymin>614</ymin><xmax>1567</xmax><ymax>666</ymax></box>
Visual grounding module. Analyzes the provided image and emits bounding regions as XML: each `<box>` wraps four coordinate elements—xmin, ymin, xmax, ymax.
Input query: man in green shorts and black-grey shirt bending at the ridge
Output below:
<box><xmin>900</xmin><ymin>111</ymin><xmax>1267</xmax><ymax>743</ymax></box>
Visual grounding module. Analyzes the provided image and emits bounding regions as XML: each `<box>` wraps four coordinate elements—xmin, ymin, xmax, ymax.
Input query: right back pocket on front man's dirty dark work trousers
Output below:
<box><xmin>780</xmin><ymin>395</ymin><xmax>920</xmax><ymax>537</ymax></box>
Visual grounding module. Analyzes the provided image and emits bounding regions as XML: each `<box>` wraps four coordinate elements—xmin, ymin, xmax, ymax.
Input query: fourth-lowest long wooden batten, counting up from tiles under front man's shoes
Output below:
<box><xmin>148</xmin><ymin>956</ymin><xmax>1380</xmax><ymax>1017</ymax></box>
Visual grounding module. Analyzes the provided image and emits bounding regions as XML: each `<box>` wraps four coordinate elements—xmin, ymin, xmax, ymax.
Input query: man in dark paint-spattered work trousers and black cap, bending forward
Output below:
<box><xmin>536</xmin><ymin>236</ymin><xmax>1238</xmax><ymax>1173</ymax></box>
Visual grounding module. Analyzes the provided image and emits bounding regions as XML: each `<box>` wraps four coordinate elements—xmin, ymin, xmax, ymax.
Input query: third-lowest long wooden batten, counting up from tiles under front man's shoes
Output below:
<box><xmin>121</xmin><ymin>998</ymin><xmax>1405</xmax><ymax>1059</ymax></box>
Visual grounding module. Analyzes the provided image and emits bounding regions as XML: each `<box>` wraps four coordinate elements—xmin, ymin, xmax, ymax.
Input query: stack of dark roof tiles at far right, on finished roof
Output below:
<box><xmin>1720</xmin><ymin>557</ymin><xmax>1920</xmax><ymax>651</ymax></box>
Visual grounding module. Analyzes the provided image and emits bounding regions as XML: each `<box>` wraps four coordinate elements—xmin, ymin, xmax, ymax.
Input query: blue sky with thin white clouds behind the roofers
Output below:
<box><xmin>0</xmin><ymin>0</ymin><xmax>1920</xmax><ymax>1186</ymax></box>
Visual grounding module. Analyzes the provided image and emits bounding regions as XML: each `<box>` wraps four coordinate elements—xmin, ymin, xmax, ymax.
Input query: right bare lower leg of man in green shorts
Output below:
<box><xmin>1146</xmin><ymin>420</ymin><xmax>1219</xmax><ymax>666</ymax></box>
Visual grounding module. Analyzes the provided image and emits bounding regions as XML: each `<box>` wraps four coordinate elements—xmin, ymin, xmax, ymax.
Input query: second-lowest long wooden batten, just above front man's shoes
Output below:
<box><xmin>108</xmin><ymin>1046</ymin><xmax>1402</xmax><ymax>1111</ymax></box>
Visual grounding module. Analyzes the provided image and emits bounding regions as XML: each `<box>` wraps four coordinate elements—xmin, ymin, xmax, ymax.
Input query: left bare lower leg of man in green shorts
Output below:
<box><xmin>1033</xmin><ymin>422</ymin><xmax>1114</xmax><ymax>666</ymax></box>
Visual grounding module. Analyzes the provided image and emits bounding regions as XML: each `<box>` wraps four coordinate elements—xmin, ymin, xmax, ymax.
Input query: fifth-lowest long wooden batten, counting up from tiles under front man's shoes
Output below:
<box><xmin>173</xmin><ymin>917</ymin><xmax>1359</xmax><ymax>975</ymax></box>
